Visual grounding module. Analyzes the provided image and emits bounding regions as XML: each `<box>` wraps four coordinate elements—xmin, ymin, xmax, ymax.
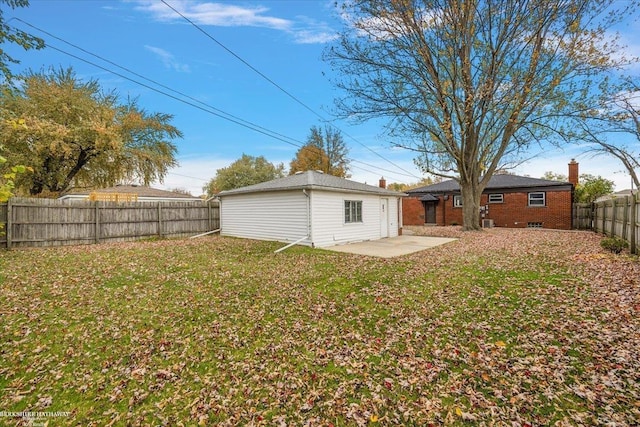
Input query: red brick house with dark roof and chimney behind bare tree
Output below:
<box><xmin>402</xmin><ymin>160</ymin><xmax>578</xmax><ymax>230</ymax></box>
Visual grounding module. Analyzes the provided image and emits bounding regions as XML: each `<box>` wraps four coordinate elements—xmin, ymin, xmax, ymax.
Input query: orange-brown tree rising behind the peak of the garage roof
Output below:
<box><xmin>289</xmin><ymin>126</ymin><xmax>349</xmax><ymax>178</ymax></box>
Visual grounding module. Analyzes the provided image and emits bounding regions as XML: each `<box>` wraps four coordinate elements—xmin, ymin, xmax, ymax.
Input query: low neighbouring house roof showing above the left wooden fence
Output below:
<box><xmin>58</xmin><ymin>185</ymin><xmax>202</xmax><ymax>202</ymax></box>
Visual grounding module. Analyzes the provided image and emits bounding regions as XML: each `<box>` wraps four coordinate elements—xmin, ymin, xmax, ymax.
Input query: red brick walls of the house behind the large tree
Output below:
<box><xmin>402</xmin><ymin>191</ymin><xmax>572</xmax><ymax>230</ymax></box>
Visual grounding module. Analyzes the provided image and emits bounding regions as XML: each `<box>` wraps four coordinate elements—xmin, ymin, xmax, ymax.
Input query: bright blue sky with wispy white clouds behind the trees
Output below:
<box><xmin>3</xmin><ymin>0</ymin><xmax>637</xmax><ymax>195</ymax></box>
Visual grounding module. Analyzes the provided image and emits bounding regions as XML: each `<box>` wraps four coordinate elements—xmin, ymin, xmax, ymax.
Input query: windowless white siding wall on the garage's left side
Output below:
<box><xmin>220</xmin><ymin>190</ymin><xmax>311</xmax><ymax>245</ymax></box>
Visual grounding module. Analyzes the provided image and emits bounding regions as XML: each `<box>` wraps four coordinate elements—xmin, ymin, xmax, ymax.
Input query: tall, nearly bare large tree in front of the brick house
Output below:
<box><xmin>326</xmin><ymin>0</ymin><xmax>635</xmax><ymax>230</ymax></box>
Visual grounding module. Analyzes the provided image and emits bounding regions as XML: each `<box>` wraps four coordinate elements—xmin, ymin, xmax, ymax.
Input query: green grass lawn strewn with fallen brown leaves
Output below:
<box><xmin>0</xmin><ymin>228</ymin><xmax>640</xmax><ymax>426</ymax></box>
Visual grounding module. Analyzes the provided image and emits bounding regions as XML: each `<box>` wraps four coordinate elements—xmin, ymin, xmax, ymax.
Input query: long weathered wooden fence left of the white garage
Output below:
<box><xmin>0</xmin><ymin>197</ymin><xmax>220</xmax><ymax>249</ymax></box>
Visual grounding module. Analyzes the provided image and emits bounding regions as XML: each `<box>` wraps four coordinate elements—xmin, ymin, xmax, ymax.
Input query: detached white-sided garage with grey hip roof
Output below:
<box><xmin>218</xmin><ymin>171</ymin><xmax>405</xmax><ymax>248</ymax></box>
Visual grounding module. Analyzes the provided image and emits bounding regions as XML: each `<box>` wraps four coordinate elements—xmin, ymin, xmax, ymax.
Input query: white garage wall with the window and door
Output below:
<box><xmin>311</xmin><ymin>190</ymin><xmax>398</xmax><ymax>247</ymax></box>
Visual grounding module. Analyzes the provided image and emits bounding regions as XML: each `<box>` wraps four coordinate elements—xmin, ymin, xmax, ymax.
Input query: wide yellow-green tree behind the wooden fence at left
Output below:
<box><xmin>0</xmin><ymin>69</ymin><xmax>182</xmax><ymax>195</ymax></box>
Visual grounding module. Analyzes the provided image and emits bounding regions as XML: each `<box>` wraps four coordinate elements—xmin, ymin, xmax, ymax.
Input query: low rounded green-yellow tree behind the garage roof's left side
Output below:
<box><xmin>202</xmin><ymin>154</ymin><xmax>284</xmax><ymax>197</ymax></box>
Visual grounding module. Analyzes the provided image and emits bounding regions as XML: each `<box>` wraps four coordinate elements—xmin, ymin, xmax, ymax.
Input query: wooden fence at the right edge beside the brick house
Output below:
<box><xmin>574</xmin><ymin>193</ymin><xmax>640</xmax><ymax>254</ymax></box>
